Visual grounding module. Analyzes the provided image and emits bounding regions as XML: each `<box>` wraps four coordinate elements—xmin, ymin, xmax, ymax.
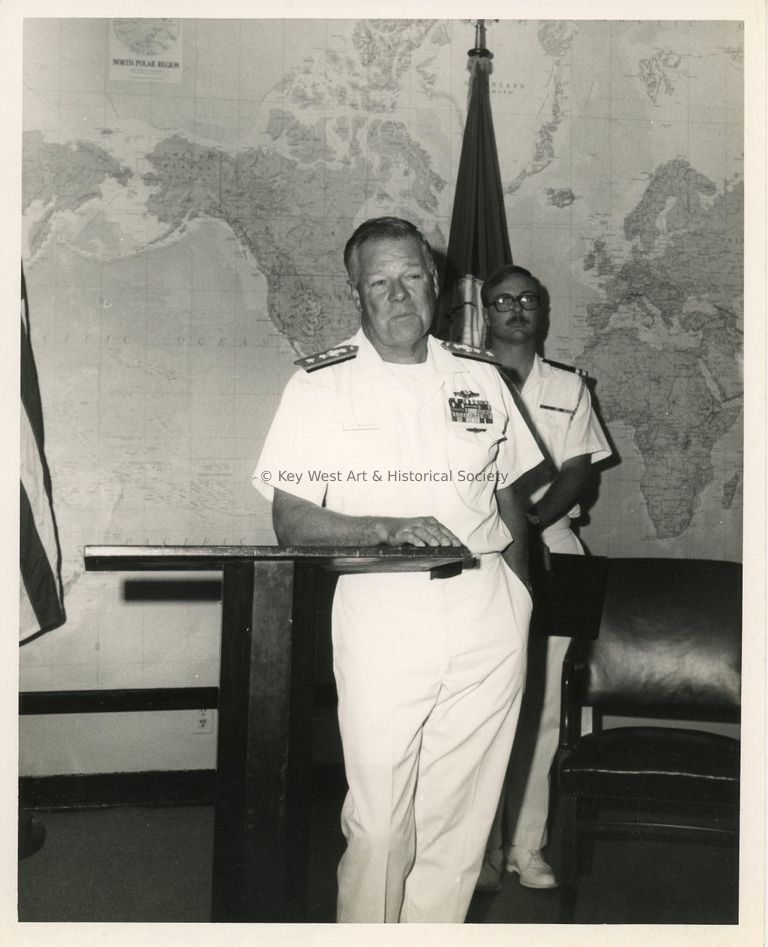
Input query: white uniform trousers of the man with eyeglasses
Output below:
<box><xmin>487</xmin><ymin>516</ymin><xmax>584</xmax><ymax>853</ymax></box>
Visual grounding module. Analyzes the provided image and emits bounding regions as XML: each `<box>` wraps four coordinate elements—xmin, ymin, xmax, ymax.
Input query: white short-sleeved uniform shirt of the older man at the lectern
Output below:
<box><xmin>253</xmin><ymin>329</ymin><xmax>541</xmax><ymax>555</ymax></box>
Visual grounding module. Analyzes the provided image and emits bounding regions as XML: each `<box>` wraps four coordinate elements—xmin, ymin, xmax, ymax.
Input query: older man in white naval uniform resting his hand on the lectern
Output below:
<box><xmin>254</xmin><ymin>218</ymin><xmax>541</xmax><ymax>922</ymax></box>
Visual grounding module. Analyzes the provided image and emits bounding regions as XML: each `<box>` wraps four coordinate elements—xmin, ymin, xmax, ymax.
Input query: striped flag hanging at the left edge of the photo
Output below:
<box><xmin>19</xmin><ymin>270</ymin><xmax>66</xmax><ymax>641</ymax></box>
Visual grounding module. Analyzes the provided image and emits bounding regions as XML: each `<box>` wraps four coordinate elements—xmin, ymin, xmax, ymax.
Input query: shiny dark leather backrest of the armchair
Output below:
<box><xmin>574</xmin><ymin>559</ymin><xmax>742</xmax><ymax>721</ymax></box>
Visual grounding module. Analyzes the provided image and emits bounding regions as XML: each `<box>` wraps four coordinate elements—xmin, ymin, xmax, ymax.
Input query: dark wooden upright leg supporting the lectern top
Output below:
<box><xmin>211</xmin><ymin>560</ymin><xmax>319</xmax><ymax>922</ymax></box>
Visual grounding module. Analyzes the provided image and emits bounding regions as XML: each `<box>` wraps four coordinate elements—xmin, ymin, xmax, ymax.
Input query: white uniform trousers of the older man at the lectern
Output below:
<box><xmin>333</xmin><ymin>554</ymin><xmax>531</xmax><ymax>923</ymax></box>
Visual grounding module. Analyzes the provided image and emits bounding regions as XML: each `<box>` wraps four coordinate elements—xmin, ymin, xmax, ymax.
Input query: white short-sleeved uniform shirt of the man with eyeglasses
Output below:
<box><xmin>520</xmin><ymin>355</ymin><xmax>611</xmax><ymax>524</ymax></box>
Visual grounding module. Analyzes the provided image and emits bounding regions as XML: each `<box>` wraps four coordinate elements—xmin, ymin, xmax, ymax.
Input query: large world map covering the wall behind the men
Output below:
<box><xmin>23</xmin><ymin>20</ymin><xmax>744</xmax><ymax>684</ymax></box>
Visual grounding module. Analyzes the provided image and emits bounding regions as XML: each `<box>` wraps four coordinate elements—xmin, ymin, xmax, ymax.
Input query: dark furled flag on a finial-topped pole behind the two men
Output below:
<box><xmin>441</xmin><ymin>20</ymin><xmax>512</xmax><ymax>346</ymax></box>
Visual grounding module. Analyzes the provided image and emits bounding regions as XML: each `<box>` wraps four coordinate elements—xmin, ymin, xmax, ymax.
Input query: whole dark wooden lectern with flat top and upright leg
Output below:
<box><xmin>84</xmin><ymin>546</ymin><xmax>471</xmax><ymax>923</ymax></box>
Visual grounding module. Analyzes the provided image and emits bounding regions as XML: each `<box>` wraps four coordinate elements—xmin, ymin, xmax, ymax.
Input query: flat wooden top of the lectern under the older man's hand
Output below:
<box><xmin>83</xmin><ymin>546</ymin><xmax>474</xmax><ymax>577</ymax></box>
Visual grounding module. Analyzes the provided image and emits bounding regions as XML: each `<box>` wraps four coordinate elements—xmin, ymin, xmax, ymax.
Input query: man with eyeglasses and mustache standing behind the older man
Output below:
<box><xmin>477</xmin><ymin>264</ymin><xmax>611</xmax><ymax>891</ymax></box>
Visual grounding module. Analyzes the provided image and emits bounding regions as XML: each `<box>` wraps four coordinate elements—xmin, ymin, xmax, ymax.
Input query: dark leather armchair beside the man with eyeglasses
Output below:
<box><xmin>558</xmin><ymin>559</ymin><xmax>742</xmax><ymax>922</ymax></box>
